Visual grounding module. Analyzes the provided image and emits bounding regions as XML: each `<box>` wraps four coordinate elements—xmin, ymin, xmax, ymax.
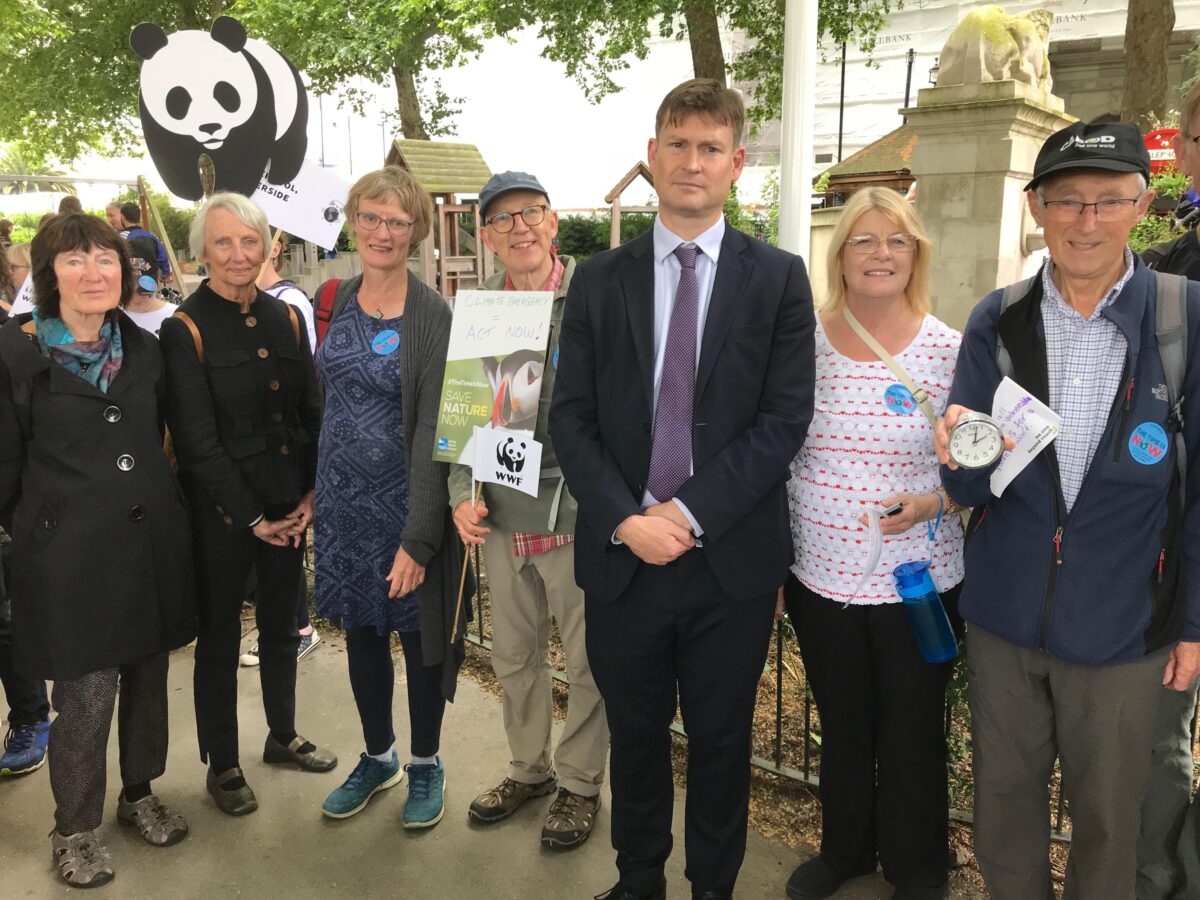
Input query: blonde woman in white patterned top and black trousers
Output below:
<box><xmin>784</xmin><ymin>187</ymin><xmax>962</xmax><ymax>900</ymax></box>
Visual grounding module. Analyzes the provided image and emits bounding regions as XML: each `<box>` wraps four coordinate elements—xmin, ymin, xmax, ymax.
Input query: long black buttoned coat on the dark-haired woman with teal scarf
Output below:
<box><xmin>0</xmin><ymin>313</ymin><xmax>196</xmax><ymax>679</ymax></box>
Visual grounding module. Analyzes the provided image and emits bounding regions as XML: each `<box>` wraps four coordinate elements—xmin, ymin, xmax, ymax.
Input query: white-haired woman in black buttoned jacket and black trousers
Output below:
<box><xmin>158</xmin><ymin>193</ymin><xmax>337</xmax><ymax>816</ymax></box>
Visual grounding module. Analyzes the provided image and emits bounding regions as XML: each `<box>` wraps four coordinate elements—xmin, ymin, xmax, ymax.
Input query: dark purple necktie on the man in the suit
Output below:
<box><xmin>646</xmin><ymin>244</ymin><xmax>700</xmax><ymax>503</ymax></box>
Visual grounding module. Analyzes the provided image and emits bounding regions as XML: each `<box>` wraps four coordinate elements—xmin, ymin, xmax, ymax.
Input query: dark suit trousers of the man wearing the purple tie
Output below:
<box><xmin>586</xmin><ymin>550</ymin><xmax>775</xmax><ymax>893</ymax></box>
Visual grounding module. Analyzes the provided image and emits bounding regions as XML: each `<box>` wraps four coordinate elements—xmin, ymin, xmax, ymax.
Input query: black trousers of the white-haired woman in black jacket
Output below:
<box><xmin>193</xmin><ymin>503</ymin><xmax>304</xmax><ymax>768</ymax></box>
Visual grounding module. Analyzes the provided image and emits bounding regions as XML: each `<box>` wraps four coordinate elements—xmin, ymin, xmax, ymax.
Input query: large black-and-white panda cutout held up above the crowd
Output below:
<box><xmin>130</xmin><ymin>16</ymin><xmax>308</xmax><ymax>200</ymax></box>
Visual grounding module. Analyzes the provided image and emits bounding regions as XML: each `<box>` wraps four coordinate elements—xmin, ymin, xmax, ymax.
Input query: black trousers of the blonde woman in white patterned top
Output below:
<box><xmin>785</xmin><ymin>576</ymin><xmax>962</xmax><ymax>887</ymax></box>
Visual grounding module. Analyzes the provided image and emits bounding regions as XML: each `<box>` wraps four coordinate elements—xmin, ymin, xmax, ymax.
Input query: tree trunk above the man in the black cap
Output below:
<box><xmin>1121</xmin><ymin>0</ymin><xmax>1175</xmax><ymax>132</ymax></box>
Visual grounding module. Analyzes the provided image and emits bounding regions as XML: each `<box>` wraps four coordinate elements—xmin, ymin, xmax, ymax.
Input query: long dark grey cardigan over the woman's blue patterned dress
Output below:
<box><xmin>329</xmin><ymin>272</ymin><xmax>474</xmax><ymax>701</ymax></box>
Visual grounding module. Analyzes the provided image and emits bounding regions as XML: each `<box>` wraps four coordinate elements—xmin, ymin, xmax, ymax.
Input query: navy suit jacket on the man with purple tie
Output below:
<box><xmin>550</xmin><ymin>227</ymin><xmax>814</xmax><ymax>600</ymax></box>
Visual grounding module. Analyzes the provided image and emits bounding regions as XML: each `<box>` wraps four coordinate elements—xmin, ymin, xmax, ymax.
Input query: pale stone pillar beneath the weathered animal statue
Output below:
<box><xmin>904</xmin><ymin>82</ymin><xmax>1074</xmax><ymax>330</ymax></box>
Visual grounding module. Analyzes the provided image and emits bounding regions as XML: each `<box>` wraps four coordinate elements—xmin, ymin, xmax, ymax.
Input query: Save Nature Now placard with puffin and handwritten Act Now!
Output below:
<box><xmin>433</xmin><ymin>290</ymin><xmax>558</xmax><ymax>466</ymax></box>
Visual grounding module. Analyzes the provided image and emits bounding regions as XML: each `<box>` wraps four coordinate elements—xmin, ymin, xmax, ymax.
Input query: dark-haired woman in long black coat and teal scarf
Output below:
<box><xmin>0</xmin><ymin>215</ymin><xmax>196</xmax><ymax>887</ymax></box>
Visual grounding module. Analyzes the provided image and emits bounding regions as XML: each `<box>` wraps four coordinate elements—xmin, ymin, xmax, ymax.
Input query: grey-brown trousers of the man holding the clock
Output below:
<box><xmin>967</xmin><ymin>626</ymin><xmax>1168</xmax><ymax>900</ymax></box>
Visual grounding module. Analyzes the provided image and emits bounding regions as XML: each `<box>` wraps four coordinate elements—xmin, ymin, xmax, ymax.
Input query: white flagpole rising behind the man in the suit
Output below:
<box><xmin>779</xmin><ymin>0</ymin><xmax>817</xmax><ymax>264</ymax></box>
